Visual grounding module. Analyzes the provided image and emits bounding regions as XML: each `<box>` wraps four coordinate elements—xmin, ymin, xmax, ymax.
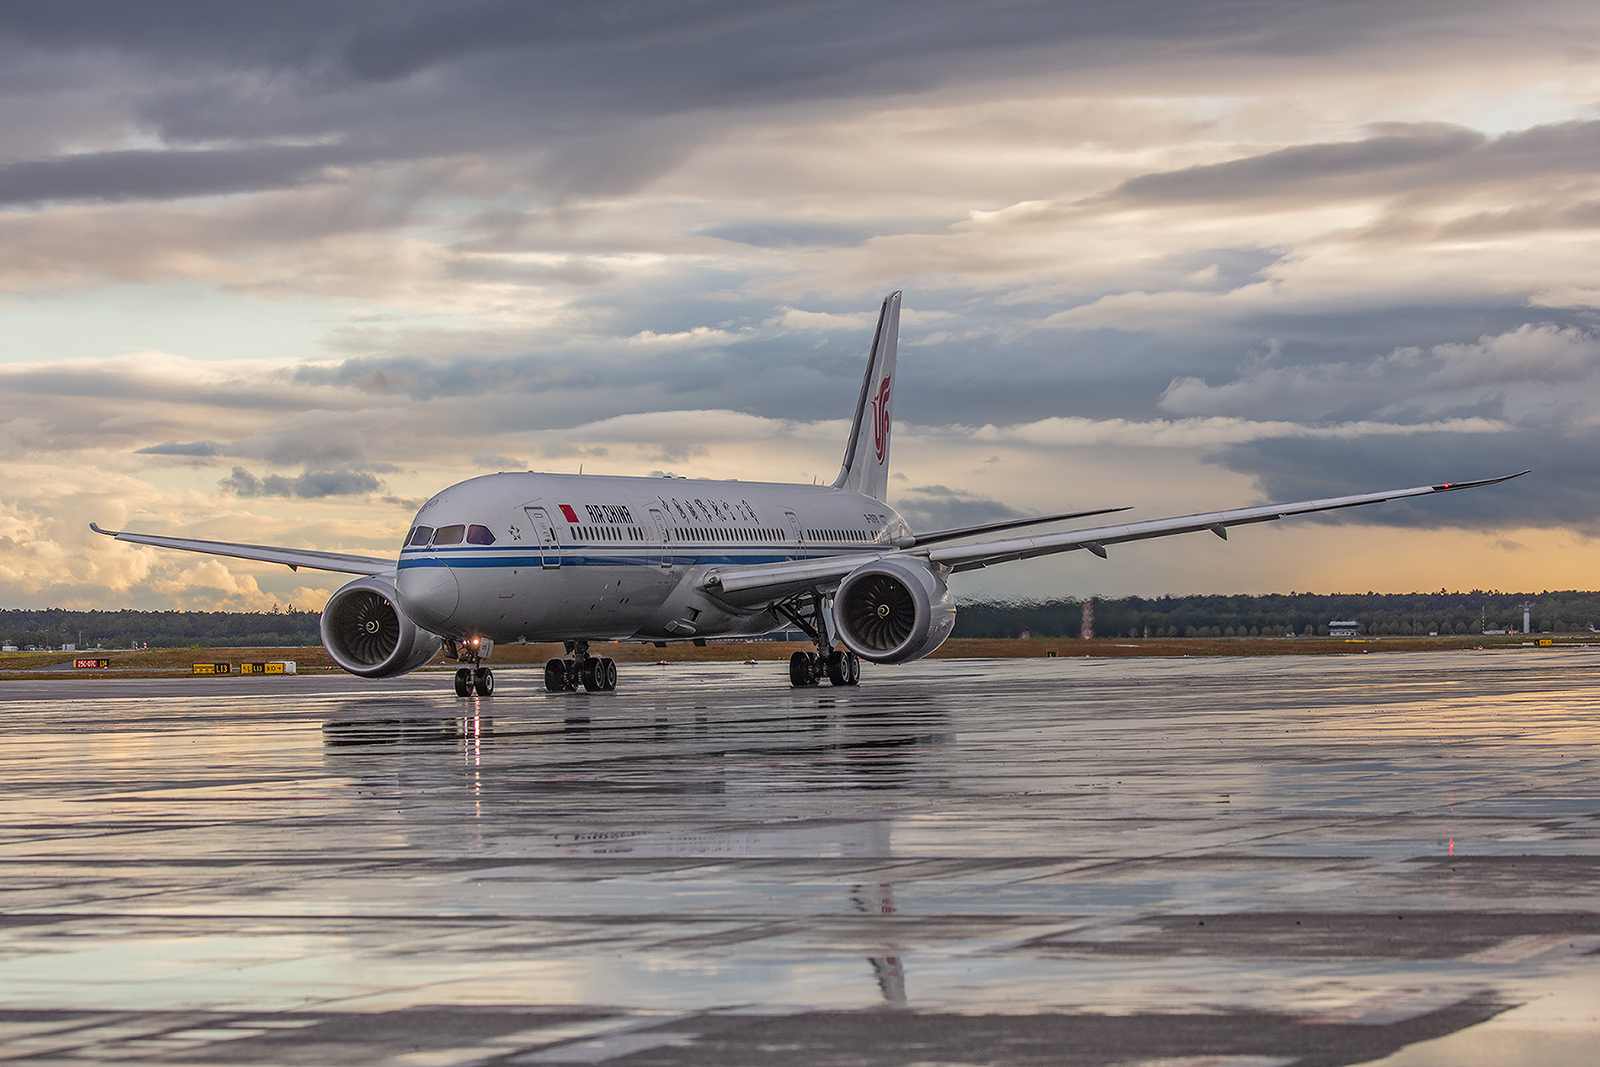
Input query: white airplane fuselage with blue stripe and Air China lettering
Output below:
<box><xmin>395</xmin><ymin>474</ymin><xmax>909</xmax><ymax>641</ymax></box>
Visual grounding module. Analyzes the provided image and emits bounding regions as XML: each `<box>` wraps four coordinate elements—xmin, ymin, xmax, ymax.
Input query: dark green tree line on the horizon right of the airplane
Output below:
<box><xmin>955</xmin><ymin>589</ymin><xmax>1600</xmax><ymax>637</ymax></box>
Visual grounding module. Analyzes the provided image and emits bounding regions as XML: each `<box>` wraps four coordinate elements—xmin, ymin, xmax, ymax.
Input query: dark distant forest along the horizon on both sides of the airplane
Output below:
<box><xmin>0</xmin><ymin>590</ymin><xmax>1600</xmax><ymax>648</ymax></box>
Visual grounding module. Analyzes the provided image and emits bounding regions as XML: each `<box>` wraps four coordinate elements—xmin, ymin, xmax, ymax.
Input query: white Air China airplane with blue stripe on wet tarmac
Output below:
<box><xmin>90</xmin><ymin>293</ymin><xmax>1528</xmax><ymax>696</ymax></box>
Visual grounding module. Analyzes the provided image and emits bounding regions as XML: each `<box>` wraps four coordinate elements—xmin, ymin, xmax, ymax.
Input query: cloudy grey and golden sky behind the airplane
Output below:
<box><xmin>0</xmin><ymin>0</ymin><xmax>1600</xmax><ymax>608</ymax></box>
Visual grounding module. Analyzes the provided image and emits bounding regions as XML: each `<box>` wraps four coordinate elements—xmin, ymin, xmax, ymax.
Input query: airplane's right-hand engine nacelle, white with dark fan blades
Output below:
<box><xmin>834</xmin><ymin>557</ymin><xmax>955</xmax><ymax>664</ymax></box>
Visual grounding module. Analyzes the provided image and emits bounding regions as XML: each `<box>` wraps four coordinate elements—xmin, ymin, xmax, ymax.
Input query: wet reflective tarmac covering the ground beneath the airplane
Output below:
<box><xmin>0</xmin><ymin>651</ymin><xmax>1600</xmax><ymax>1067</ymax></box>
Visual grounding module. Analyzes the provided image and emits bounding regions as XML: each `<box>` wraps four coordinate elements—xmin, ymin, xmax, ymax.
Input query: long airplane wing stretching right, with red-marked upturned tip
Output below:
<box><xmin>702</xmin><ymin>470</ymin><xmax>1528</xmax><ymax>605</ymax></box>
